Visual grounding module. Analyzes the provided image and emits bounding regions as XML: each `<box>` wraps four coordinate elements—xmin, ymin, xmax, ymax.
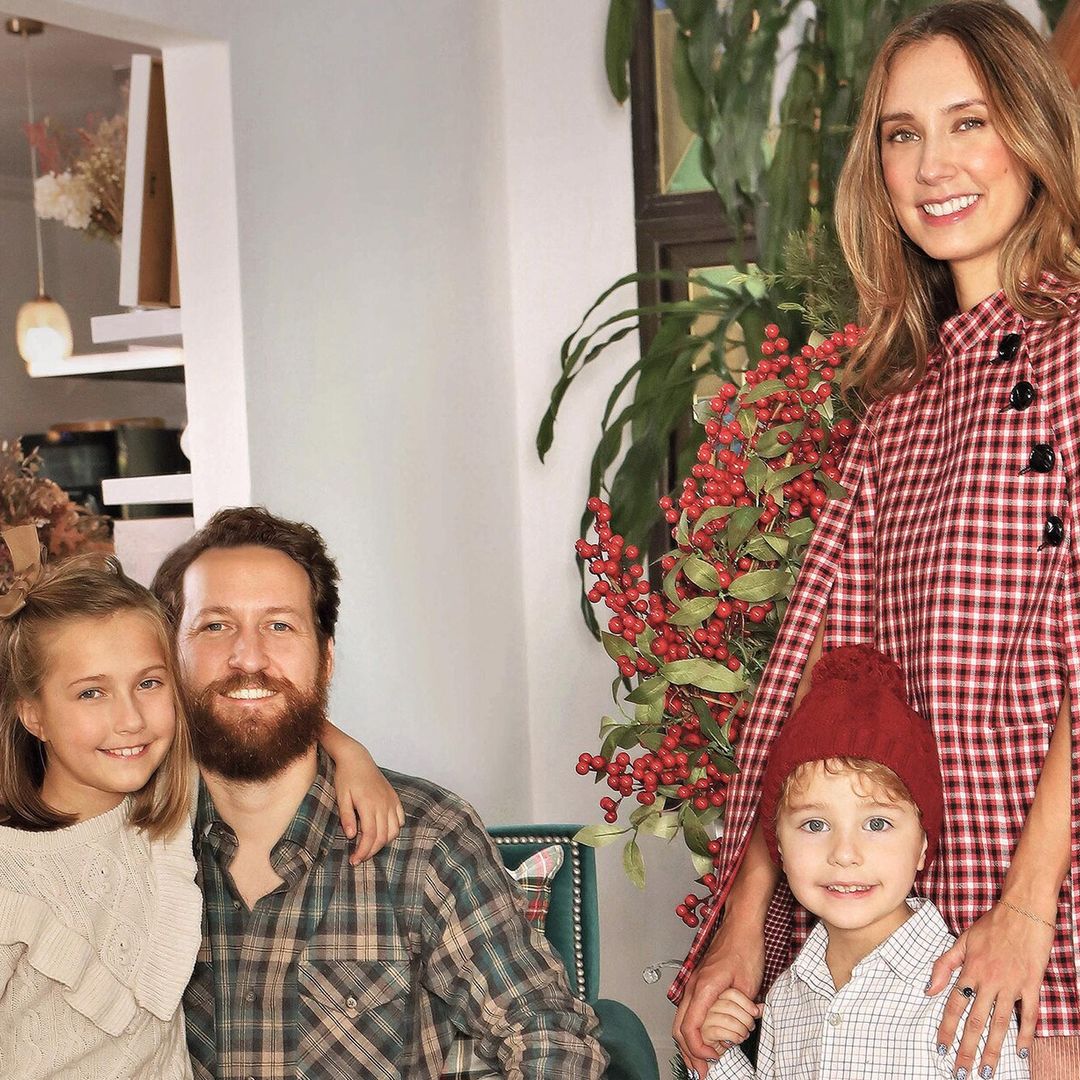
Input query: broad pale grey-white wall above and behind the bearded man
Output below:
<box><xmin>35</xmin><ymin>0</ymin><xmax>531</xmax><ymax>821</ymax></box>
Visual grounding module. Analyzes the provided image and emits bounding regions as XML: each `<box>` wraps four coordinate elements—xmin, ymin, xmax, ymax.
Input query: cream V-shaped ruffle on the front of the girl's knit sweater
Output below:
<box><xmin>0</xmin><ymin>812</ymin><xmax>202</xmax><ymax>1036</ymax></box>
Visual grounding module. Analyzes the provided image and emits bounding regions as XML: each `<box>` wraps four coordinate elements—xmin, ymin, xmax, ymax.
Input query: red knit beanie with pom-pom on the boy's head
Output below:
<box><xmin>759</xmin><ymin>645</ymin><xmax>944</xmax><ymax>866</ymax></box>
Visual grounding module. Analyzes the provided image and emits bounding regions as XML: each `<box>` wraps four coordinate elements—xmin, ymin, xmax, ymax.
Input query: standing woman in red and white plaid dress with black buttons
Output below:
<box><xmin>672</xmin><ymin>0</ymin><xmax>1080</xmax><ymax>1080</ymax></box>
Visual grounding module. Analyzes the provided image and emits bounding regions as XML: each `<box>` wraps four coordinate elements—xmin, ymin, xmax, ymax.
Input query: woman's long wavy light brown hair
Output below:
<box><xmin>836</xmin><ymin>0</ymin><xmax>1080</xmax><ymax>403</ymax></box>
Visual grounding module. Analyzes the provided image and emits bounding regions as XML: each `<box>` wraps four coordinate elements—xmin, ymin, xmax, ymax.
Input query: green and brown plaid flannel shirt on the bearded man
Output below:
<box><xmin>184</xmin><ymin>751</ymin><xmax>605</xmax><ymax>1080</ymax></box>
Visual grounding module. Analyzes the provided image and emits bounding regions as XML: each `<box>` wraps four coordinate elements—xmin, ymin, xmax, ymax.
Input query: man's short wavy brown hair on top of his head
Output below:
<box><xmin>150</xmin><ymin>507</ymin><xmax>340</xmax><ymax>649</ymax></box>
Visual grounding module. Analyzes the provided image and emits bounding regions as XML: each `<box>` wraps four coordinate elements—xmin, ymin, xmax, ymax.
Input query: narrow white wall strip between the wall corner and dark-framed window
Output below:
<box><xmin>500</xmin><ymin>0</ymin><xmax>690</xmax><ymax>1062</ymax></box>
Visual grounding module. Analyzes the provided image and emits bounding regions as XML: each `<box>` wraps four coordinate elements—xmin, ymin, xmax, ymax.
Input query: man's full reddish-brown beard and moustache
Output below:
<box><xmin>187</xmin><ymin>672</ymin><xmax>328</xmax><ymax>783</ymax></box>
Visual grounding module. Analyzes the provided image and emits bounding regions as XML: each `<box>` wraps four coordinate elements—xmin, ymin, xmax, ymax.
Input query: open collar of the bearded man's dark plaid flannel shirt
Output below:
<box><xmin>195</xmin><ymin>746</ymin><xmax>338</xmax><ymax>886</ymax></box>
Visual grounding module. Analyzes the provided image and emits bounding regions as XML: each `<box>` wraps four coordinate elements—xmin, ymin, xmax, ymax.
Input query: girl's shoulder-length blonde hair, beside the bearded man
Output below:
<box><xmin>0</xmin><ymin>555</ymin><xmax>192</xmax><ymax>839</ymax></box>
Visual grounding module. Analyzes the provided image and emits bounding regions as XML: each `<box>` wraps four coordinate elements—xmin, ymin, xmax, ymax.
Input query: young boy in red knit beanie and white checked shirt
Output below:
<box><xmin>702</xmin><ymin>645</ymin><xmax>1029</xmax><ymax>1080</ymax></box>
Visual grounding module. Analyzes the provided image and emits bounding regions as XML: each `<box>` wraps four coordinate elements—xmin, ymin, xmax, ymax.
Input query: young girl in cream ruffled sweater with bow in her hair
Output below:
<box><xmin>0</xmin><ymin>526</ymin><xmax>397</xmax><ymax>1080</ymax></box>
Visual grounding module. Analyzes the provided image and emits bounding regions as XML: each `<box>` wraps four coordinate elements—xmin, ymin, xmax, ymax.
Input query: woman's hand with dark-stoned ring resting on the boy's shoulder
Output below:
<box><xmin>927</xmin><ymin>904</ymin><xmax>1054</xmax><ymax>1076</ymax></box>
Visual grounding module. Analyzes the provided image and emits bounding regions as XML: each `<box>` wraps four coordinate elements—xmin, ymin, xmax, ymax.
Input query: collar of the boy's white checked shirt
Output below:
<box><xmin>792</xmin><ymin>896</ymin><xmax>949</xmax><ymax>997</ymax></box>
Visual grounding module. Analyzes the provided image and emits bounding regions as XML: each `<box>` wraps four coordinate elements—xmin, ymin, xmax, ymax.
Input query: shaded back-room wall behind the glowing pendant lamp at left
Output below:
<box><xmin>0</xmin><ymin>181</ymin><xmax>185</xmax><ymax>438</ymax></box>
